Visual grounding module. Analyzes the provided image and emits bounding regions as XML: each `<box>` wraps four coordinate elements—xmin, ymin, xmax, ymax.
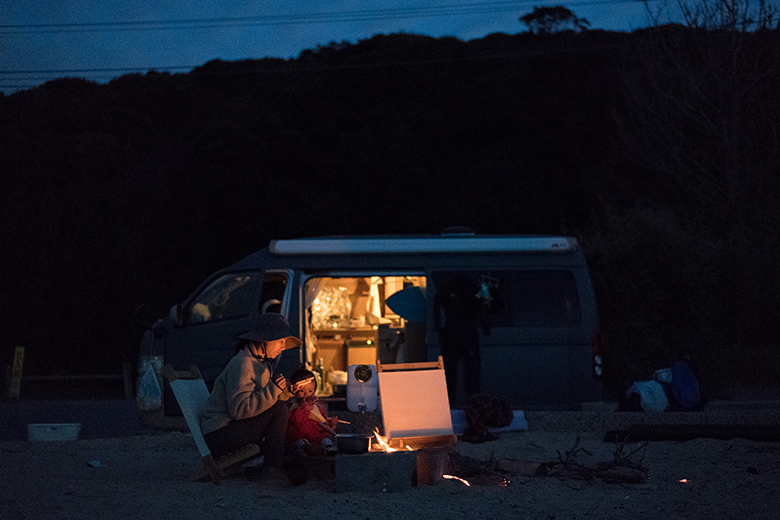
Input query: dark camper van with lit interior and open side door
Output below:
<box><xmin>139</xmin><ymin>233</ymin><xmax>602</xmax><ymax>414</ymax></box>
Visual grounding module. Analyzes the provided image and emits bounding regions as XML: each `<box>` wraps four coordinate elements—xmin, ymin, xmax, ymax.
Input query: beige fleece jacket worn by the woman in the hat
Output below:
<box><xmin>200</xmin><ymin>343</ymin><xmax>290</xmax><ymax>435</ymax></box>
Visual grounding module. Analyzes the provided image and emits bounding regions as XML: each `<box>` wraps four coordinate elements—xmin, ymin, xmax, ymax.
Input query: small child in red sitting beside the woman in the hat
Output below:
<box><xmin>287</xmin><ymin>369</ymin><xmax>338</xmax><ymax>457</ymax></box>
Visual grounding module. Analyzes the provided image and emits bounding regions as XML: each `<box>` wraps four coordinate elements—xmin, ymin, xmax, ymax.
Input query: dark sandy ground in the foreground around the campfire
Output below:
<box><xmin>0</xmin><ymin>414</ymin><xmax>780</xmax><ymax>520</ymax></box>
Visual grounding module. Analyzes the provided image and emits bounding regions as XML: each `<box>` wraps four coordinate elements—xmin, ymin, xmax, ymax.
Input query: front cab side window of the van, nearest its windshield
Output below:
<box><xmin>185</xmin><ymin>273</ymin><xmax>261</xmax><ymax>325</ymax></box>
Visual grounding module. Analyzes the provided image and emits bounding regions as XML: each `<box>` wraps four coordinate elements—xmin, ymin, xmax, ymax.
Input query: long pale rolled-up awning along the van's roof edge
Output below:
<box><xmin>268</xmin><ymin>234</ymin><xmax>577</xmax><ymax>255</ymax></box>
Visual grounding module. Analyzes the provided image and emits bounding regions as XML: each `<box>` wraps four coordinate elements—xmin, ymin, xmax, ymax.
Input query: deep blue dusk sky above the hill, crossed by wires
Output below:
<box><xmin>0</xmin><ymin>0</ymin><xmax>672</xmax><ymax>93</ymax></box>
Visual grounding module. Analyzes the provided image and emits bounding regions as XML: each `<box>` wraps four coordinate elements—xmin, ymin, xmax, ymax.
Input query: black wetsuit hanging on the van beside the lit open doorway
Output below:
<box><xmin>434</xmin><ymin>274</ymin><xmax>490</xmax><ymax>403</ymax></box>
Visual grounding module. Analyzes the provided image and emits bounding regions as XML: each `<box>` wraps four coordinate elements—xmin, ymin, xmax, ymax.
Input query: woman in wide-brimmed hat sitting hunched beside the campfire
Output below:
<box><xmin>200</xmin><ymin>313</ymin><xmax>301</xmax><ymax>478</ymax></box>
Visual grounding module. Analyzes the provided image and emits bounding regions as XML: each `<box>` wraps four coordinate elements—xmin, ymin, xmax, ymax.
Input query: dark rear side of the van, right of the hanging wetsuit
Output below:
<box><xmin>433</xmin><ymin>268</ymin><xmax>595</xmax><ymax>409</ymax></box>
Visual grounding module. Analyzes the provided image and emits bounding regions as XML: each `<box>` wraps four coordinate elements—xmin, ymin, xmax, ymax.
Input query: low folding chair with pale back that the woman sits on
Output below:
<box><xmin>165</xmin><ymin>363</ymin><xmax>260</xmax><ymax>484</ymax></box>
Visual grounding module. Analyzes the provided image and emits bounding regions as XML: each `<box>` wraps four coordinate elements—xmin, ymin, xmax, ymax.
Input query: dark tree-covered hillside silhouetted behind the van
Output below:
<box><xmin>0</xmin><ymin>26</ymin><xmax>780</xmax><ymax>392</ymax></box>
